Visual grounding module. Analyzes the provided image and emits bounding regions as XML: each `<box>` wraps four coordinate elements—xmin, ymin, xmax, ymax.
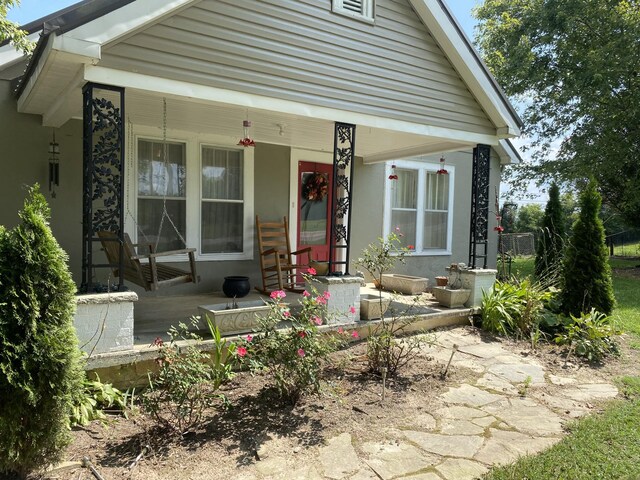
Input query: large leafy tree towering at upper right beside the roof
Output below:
<box><xmin>474</xmin><ymin>0</ymin><xmax>640</xmax><ymax>226</ymax></box>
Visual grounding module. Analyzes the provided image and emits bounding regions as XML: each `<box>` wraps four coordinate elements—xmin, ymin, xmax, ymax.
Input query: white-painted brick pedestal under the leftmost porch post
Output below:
<box><xmin>73</xmin><ymin>292</ymin><xmax>138</xmax><ymax>355</ymax></box>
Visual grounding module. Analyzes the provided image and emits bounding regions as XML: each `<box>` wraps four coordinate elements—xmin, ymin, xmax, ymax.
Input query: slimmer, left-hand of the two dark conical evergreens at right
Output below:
<box><xmin>535</xmin><ymin>183</ymin><xmax>565</xmax><ymax>280</ymax></box>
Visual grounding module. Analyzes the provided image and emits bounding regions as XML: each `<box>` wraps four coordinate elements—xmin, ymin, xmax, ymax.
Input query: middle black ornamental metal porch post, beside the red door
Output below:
<box><xmin>329</xmin><ymin>122</ymin><xmax>356</xmax><ymax>275</ymax></box>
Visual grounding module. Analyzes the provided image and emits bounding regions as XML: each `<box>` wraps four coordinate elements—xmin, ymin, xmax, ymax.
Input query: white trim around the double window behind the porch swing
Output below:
<box><xmin>124</xmin><ymin>125</ymin><xmax>255</xmax><ymax>262</ymax></box>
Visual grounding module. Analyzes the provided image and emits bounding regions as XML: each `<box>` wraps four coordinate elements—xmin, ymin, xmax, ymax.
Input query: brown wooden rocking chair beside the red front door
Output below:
<box><xmin>256</xmin><ymin>215</ymin><xmax>311</xmax><ymax>295</ymax></box>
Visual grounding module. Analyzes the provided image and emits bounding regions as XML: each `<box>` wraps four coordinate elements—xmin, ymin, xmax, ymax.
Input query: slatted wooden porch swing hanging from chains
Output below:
<box><xmin>98</xmin><ymin>231</ymin><xmax>199</xmax><ymax>292</ymax></box>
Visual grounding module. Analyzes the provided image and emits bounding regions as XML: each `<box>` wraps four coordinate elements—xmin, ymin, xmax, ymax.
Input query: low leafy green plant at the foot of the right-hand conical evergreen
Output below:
<box><xmin>556</xmin><ymin>309</ymin><xmax>620</xmax><ymax>363</ymax></box>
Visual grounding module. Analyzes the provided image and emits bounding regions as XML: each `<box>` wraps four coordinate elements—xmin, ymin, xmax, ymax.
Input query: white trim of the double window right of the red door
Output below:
<box><xmin>383</xmin><ymin>160</ymin><xmax>456</xmax><ymax>257</ymax></box>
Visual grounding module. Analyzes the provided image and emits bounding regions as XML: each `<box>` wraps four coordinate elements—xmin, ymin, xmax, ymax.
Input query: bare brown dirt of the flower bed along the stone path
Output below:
<box><xmin>46</xmin><ymin>326</ymin><xmax>640</xmax><ymax>480</ymax></box>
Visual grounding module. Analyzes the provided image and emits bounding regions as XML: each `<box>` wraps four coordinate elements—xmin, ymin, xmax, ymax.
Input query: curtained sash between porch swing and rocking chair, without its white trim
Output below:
<box><xmin>200</xmin><ymin>145</ymin><xmax>244</xmax><ymax>254</ymax></box>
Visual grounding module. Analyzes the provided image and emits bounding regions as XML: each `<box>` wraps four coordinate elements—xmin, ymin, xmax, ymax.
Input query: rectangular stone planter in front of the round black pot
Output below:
<box><xmin>198</xmin><ymin>300</ymin><xmax>269</xmax><ymax>335</ymax></box>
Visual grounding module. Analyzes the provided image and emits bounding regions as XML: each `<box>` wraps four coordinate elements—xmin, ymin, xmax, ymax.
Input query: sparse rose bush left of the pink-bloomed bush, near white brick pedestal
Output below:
<box><xmin>142</xmin><ymin>318</ymin><xmax>237</xmax><ymax>435</ymax></box>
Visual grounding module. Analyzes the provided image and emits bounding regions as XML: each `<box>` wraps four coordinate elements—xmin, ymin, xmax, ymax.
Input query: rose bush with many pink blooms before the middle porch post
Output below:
<box><xmin>238</xmin><ymin>284</ymin><xmax>344</xmax><ymax>404</ymax></box>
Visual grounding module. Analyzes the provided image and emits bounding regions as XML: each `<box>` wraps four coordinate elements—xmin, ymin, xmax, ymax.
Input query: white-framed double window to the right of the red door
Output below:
<box><xmin>385</xmin><ymin>161</ymin><xmax>455</xmax><ymax>255</ymax></box>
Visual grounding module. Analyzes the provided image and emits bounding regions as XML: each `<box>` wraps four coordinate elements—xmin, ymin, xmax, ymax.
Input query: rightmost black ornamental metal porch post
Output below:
<box><xmin>469</xmin><ymin>145</ymin><xmax>491</xmax><ymax>268</ymax></box>
